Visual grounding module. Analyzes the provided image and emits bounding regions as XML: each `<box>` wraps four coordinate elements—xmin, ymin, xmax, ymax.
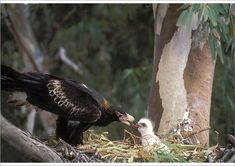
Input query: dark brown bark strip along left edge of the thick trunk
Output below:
<box><xmin>148</xmin><ymin>4</ymin><xmax>182</xmax><ymax>134</ymax></box>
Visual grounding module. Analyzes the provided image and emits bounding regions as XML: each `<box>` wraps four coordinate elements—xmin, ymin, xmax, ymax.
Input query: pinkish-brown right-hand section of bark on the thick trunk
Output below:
<box><xmin>184</xmin><ymin>40</ymin><xmax>215</xmax><ymax>145</ymax></box>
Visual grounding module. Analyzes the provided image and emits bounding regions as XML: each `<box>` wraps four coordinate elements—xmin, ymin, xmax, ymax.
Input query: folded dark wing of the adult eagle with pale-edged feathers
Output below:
<box><xmin>47</xmin><ymin>79</ymin><xmax>101</xmax><ymax>123</ymax></box>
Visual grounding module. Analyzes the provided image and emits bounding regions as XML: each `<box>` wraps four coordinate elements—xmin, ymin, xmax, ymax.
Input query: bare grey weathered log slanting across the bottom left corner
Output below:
<box><xmin>0</xmin><ymin>114</ymin><xmax>63</xmax><ymax>162</ymax></box>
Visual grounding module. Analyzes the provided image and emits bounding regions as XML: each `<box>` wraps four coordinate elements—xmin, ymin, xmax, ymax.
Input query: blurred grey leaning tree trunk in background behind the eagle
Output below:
<box><xmin>2</xmin><ymin>4</ymin><xmax>56</xmax><ymax>135</ymax></box>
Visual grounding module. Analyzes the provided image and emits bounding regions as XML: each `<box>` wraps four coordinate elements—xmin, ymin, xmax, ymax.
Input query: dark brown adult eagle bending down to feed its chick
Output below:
<box><xmin>1</xmin><ymin>65</ymin><xmax>134</xmax><ymax>145</ymax></box>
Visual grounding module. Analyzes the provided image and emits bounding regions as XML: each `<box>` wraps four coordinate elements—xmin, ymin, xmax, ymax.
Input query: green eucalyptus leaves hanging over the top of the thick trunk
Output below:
<box><xmin>177</xmin><ymin>4</ymin><xmax>235</xmax><ymax>64</ymax></box>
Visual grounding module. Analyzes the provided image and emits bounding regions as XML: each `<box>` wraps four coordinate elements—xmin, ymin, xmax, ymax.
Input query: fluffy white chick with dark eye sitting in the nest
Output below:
<box><xmin>134</xmin><ymin>118</ymin><xmax>170</xmax><ymax>152</ymax></box>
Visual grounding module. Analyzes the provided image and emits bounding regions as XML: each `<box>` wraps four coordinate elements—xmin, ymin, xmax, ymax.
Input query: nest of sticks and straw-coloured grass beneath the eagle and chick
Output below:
<box><xmin>44</xmin><ymin>130</ymin><xmax>234</xmax><ymax>163</ymax></box>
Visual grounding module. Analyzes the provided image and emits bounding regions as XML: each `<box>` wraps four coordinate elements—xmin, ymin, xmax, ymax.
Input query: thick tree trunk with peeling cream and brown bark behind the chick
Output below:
<box><xmin>148</xmin><ymin>4</ymin><xmax>215</xmax><ymax>145</ymax></box>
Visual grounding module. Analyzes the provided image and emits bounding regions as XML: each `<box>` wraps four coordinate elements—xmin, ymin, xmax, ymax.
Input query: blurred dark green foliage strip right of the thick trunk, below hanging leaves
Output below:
<box><xmin>211</xmin><ymin>56</ymin><xmax>235</xmax><ymax>144</ymax></box>
